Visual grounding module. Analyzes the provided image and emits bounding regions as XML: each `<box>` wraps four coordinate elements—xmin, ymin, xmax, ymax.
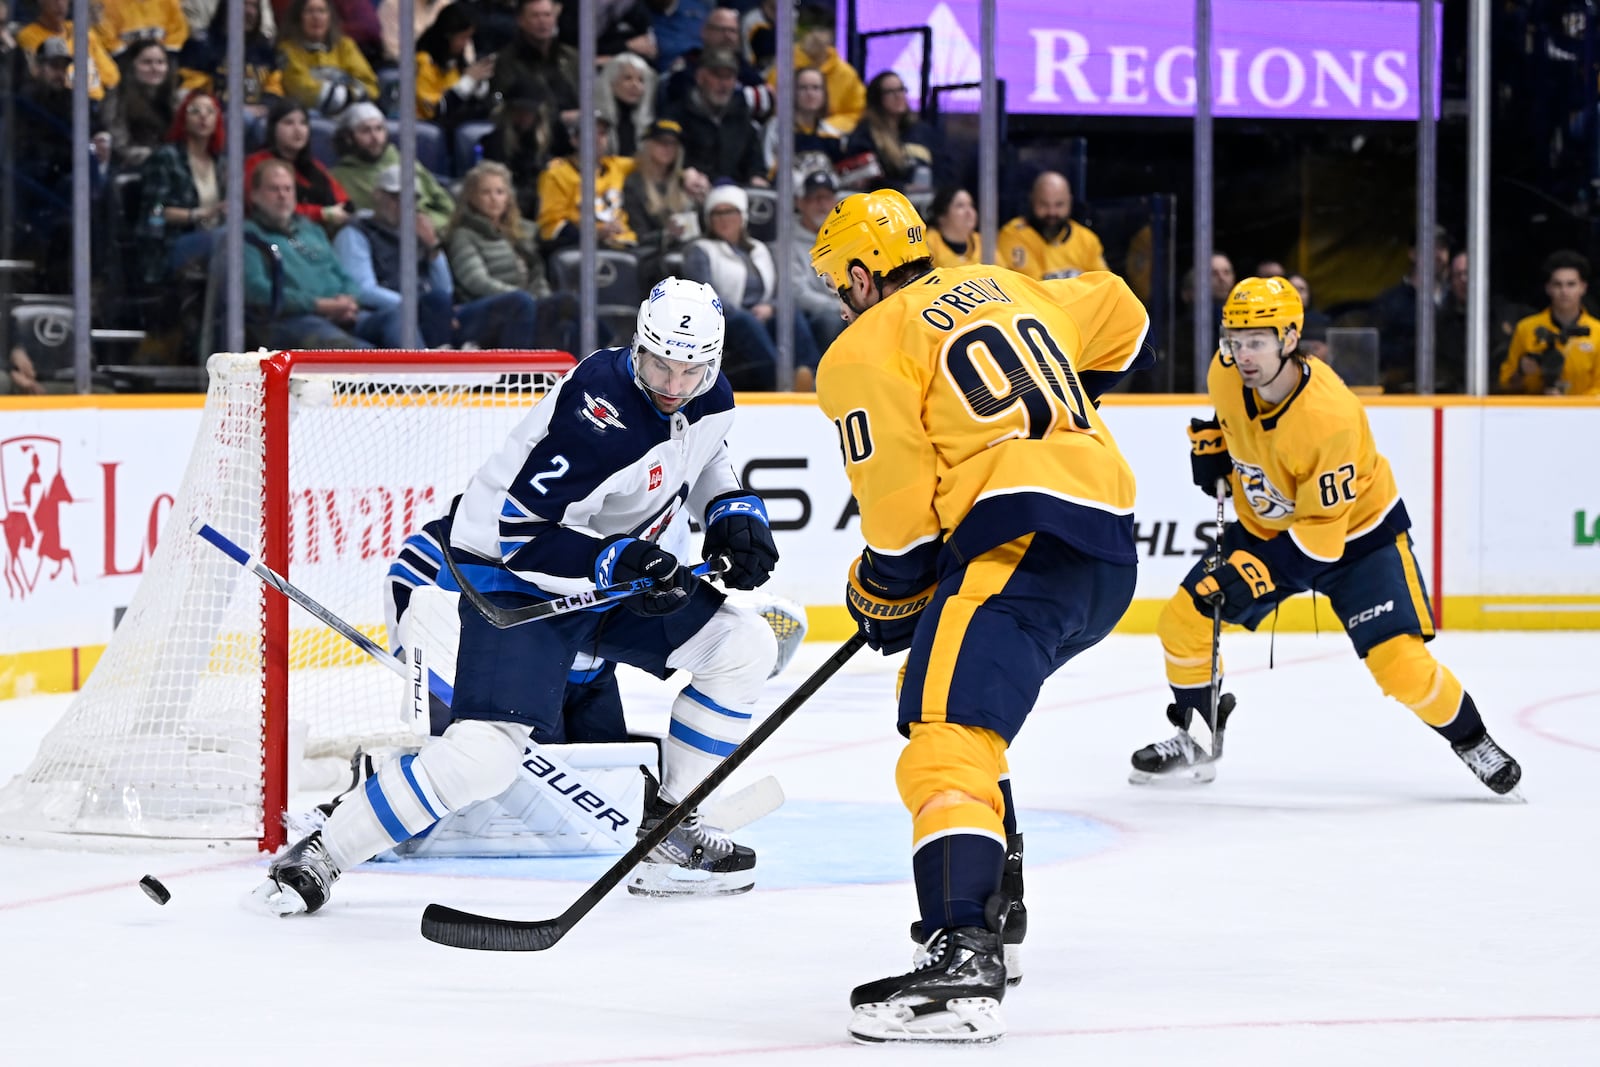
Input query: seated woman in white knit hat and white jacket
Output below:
<box><xmin>682</xmin><ymin>186</ymin><xmax>821</xmax><ymax>392</ymax></box>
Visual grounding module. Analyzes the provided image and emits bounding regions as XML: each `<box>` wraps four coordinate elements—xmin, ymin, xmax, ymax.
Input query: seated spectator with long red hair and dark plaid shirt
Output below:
<box><xmin>139</xmin><ymin>90</ymin><xmax>227</xmax><ymax>285</ymax></box>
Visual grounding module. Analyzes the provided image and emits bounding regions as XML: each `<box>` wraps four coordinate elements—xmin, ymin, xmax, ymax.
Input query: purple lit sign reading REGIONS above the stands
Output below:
<box><xmin>838</xmin><ymin>0</ymin><xmax>1442</xmax><ymax>122</ymax></box>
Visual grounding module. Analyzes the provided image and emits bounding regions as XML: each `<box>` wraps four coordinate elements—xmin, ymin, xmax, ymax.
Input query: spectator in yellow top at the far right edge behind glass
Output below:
<box><xmin>1499</xmin><ymin>251</ymin><xmax>1600</xmax><ymax>397</ymax></box>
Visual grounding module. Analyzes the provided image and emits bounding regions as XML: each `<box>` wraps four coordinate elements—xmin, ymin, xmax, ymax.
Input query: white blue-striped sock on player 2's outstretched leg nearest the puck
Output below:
<box><xmin>322</xmin><ymin>720</ymin><xmax>526</xmax><ymax>870</ymax></box>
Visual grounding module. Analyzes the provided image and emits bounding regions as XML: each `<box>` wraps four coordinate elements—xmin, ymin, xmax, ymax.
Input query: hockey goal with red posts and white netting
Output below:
<box><xmin>0</xmin><ymin>352</ymin><xmax>573</xmax><ymax>849</ymax></box>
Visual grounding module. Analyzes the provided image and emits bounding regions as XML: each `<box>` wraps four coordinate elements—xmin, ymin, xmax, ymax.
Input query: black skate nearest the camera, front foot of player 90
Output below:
<box><xmin>850</xmin><ymin>926</ymin><xmax>1006</xmax><ymax>1045</ymax></box>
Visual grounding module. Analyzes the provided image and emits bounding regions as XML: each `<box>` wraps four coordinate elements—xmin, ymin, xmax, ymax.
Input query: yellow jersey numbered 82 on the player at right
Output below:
<box><xmin>1206</xmin><ymin>357</ymin><xmax>1411</xmax><ymax>584</ymax></box>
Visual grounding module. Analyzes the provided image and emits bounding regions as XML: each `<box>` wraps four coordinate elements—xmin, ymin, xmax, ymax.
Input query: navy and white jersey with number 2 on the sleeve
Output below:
<box><xmin>450</xmin><ymin>349</ymin><xmax>741</xmax><ymax>595</ymax></box>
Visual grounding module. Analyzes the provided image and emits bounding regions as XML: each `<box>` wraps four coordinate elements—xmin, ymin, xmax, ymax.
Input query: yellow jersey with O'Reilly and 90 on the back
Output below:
<box><xmin>816</xmin><ymin>266</ymin><xmax>1152</xmax><ymax>589</ymax></box>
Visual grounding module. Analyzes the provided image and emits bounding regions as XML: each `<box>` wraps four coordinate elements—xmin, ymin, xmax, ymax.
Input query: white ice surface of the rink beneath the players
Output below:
<box><xmin>0</xmin><ymin>633</ymin><xmax>1600</xmax><ymax>1067</ymax></box>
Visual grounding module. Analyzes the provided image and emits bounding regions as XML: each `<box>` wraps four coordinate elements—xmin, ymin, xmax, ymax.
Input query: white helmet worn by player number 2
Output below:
<box><xmin>634</xmin><ymin>278</ymin><xmax>726</xmax><ymax>400</ymax></box>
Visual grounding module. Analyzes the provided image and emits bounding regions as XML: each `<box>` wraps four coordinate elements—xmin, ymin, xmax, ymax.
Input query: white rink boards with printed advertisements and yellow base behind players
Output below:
<box><xmin>0</xmin><ymin>397</ymin><xmax>1600</xmax><ymax>697</ymax></box>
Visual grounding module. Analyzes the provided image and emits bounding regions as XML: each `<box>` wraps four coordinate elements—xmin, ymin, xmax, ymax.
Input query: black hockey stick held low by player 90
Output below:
<box><xmin>422</xmin><ymin>633</ymin><xmax>867</xmax><ymax>952</ymax></box>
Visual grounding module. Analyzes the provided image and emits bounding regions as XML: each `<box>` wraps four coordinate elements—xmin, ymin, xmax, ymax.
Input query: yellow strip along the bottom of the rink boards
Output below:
<box><xmin>12</xmin><ymin>595</ymin><xmax>1600</xmax><ymax>701</ymax></box>
